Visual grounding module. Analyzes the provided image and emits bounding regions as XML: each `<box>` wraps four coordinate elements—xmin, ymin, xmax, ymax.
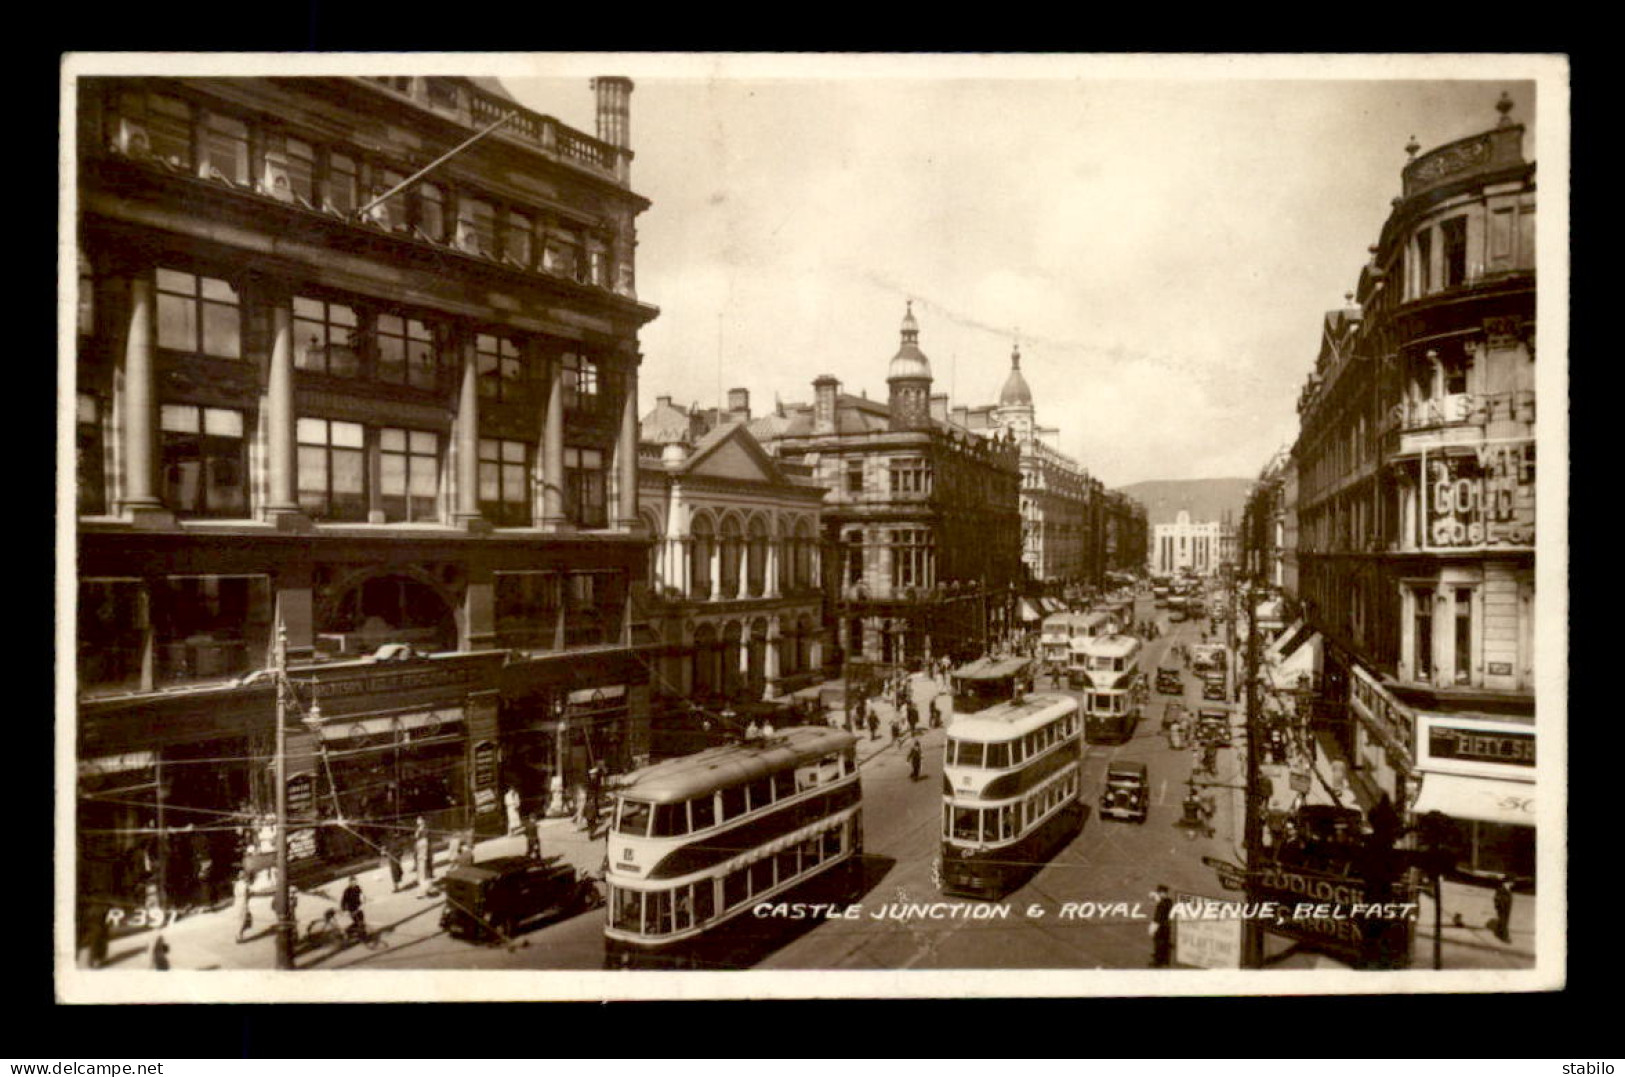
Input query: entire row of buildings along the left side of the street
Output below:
<box><xmin>68</xmin><ymin>69</ymin><xmax>1144</xmax><ymax>903</ymax></box>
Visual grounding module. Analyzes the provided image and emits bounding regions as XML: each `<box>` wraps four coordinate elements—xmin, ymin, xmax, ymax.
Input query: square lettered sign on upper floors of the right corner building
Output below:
<box><xmin>1422</xmin><ymin>439</ymin><xmax>1534</xmax><ymax>549</ymax></box>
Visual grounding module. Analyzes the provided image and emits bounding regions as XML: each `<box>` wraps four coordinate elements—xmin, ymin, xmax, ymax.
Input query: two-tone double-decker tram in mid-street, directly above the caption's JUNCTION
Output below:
<box><xmin>939</xmin><ymin>694</ymin><xmax>1084</xmax><ymax>898</ymax></box>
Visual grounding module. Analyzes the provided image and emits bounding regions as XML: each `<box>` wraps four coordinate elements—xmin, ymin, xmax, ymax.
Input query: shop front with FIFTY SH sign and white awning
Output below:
<box><xmin>1412</xmin><ymin>712</ymin><xmax>1536</xmax><ymax>879</ymax></box>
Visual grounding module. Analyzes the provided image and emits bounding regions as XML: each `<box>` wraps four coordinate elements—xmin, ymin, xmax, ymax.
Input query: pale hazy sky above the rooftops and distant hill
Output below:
<box><xmin>491</xmin><ymin>54</ymin><xmax>1567</xmax><ymax>486</ymax></box>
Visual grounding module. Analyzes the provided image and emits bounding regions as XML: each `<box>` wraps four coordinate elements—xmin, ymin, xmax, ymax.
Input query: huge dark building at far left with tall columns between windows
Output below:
<box><xmin>75</xmin><ymin>76</ymin><xmax>657</xmax><ymax>905</ymax></box>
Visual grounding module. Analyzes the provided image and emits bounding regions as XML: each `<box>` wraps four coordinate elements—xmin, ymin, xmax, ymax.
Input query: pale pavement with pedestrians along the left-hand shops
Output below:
<box><xmin>78</xmin><ymin>674</ymin><xmax>943</xmax><ymax>970</ymax></box>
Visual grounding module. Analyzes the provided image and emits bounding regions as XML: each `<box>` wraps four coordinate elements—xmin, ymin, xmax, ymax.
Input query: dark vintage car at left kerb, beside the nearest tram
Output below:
<box><xmin>440</xmin><ymin>856</ymin><xmax>603</xmax><ymax>942</ymax></box>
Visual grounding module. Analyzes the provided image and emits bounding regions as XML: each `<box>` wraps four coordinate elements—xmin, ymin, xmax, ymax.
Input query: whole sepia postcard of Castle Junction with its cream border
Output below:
<box><xmin>54</xmin><ymin>52</ymin><xmax>1570</xmax><ymax>1004</ymax></box>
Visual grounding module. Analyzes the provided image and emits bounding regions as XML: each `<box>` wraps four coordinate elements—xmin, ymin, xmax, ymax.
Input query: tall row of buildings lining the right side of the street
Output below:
<box><xmin>1243</xmin><ymin>96</ymin><xmax>1534</xmax><ymax>879</ymax></box>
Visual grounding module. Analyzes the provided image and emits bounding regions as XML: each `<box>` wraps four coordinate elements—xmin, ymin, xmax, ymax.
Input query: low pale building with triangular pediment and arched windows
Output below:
<box><xmin>639</xmin><ymin>390</ymin><xmax>826</xmax><ymax>747</ymax></box>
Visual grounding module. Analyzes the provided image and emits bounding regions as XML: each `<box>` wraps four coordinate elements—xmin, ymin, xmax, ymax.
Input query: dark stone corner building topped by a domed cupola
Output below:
<box><xmin>752</xmin><ymin>309</ymin><xmax>1022</xmax><ymax>666</ymax></box>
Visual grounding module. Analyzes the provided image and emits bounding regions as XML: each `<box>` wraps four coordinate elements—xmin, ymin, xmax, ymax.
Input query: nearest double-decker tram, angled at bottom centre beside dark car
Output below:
<box><xmin>605</xmin><ymin>726</ymin><xmax>863</xmax><ymax>965</ymax></box>
